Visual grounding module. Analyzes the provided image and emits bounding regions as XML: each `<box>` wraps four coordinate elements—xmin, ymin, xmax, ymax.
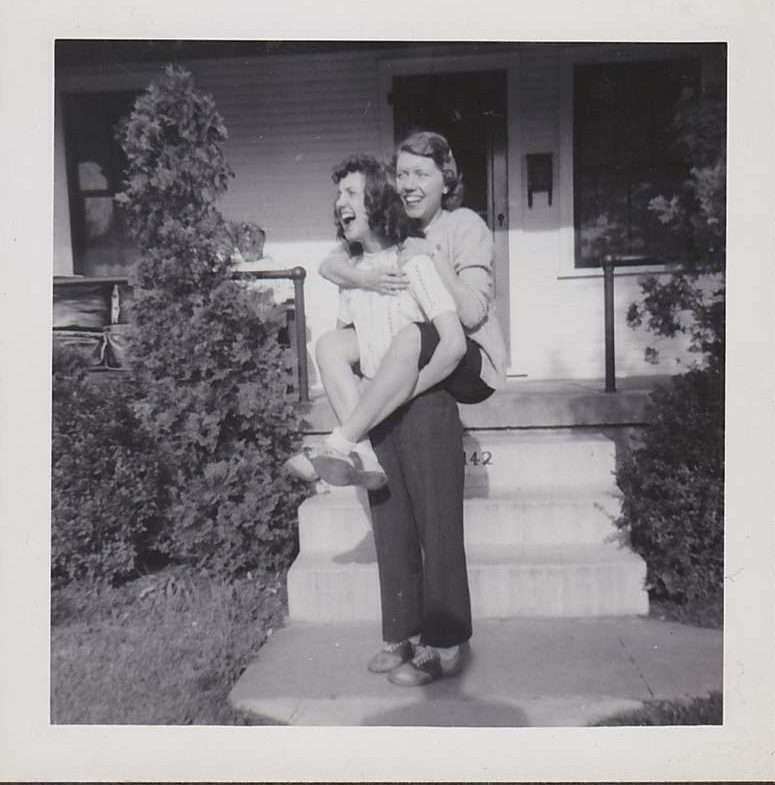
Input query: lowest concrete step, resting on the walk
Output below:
<box><xmin>288</xmin><ymin>538</ymin><xmax>648</xmax><ymax>622</ymax></box>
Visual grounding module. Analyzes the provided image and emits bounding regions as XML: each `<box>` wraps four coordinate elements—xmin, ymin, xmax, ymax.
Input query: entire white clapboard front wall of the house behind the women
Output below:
<box><xmin>55</xmin><ymin>45</ymin><xmax>716</xmax><ymax>383</ymax></box>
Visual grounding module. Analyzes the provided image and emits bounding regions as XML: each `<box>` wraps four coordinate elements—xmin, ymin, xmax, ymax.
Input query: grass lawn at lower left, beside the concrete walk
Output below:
<box><xmin>51</xmin><ymin>568</ymin><xmax>286</xmax><ymax>725</ymax></box>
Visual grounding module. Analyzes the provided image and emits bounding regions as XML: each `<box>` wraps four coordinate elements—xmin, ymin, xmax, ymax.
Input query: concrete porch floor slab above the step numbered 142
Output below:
<box><xmin>304</xmin><ymin>376</ymin><xmax>670</xmax><ymax>434</ymax></box>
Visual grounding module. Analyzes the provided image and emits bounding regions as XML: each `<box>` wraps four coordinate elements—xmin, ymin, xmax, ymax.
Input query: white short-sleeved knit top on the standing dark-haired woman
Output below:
<box><xmin>338</xmin><ymin>246</ymin><xmax>457</xmax><ymax>379</ymax></box>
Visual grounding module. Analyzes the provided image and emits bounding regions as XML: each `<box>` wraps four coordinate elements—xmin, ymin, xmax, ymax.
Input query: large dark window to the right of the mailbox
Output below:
<box><xmin>573</xmin><ymin>59</ymin><xmax>700</xmax><ymax>267</ymax></box>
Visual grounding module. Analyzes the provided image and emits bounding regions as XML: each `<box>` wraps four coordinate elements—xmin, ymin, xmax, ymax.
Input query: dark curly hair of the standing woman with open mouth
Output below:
<box><xmin>332</xmin><ymin>154</ymin><xmax>425</xmax><ymax>256</ymax></box>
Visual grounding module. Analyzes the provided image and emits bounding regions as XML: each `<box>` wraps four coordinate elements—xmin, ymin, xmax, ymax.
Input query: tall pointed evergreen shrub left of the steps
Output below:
<box><xmin>118</xmin><ymin>67</ymin><xmax>310</xmax><ymax>575</ymax></box>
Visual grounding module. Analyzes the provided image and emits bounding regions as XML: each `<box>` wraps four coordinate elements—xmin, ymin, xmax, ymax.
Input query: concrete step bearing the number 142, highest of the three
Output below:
<box><xmin>305</xmin><ymin>428</ymin><xmax>616</xmax><ymax>494</ymax></box>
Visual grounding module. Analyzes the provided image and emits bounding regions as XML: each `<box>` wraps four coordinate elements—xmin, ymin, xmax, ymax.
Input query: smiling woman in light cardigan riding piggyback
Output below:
<box><xmin>289</xmin><ymin>132</ymin><xmax>505</xmax><ymax>489</ymax></box>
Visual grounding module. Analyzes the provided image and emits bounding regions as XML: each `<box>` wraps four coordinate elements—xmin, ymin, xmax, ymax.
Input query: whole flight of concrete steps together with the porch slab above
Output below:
<box><xmin>288</xmin><ymin>377</ymin><xmax>667</xmax><ymax>623</ymax></box>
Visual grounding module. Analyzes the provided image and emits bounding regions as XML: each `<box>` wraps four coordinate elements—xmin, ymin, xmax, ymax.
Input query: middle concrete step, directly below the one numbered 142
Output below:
<box><xmin>299</xmin><ymin>488</ymin><xmax>620</xmax><ymax>553</ymax></box>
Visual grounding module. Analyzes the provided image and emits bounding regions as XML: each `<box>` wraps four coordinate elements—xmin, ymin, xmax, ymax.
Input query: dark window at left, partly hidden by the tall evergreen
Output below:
<box><xmin>63</xmin><ymin>92</ymin><xmax>137</xmax><ymax>276</ymax></box>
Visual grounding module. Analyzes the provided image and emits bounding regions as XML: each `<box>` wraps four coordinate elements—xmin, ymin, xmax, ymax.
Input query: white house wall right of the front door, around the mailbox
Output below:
<box><xmin>509</xmin><ymin>45</ymin><xmax>691</xmax><ymax>379</ymax></box>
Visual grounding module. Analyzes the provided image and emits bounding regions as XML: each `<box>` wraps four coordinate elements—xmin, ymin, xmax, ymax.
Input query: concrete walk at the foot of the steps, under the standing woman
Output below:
<box><xmin>230</xmin><ymin>617</ymin><xmax>723</xmax><ymax>727</ymax></box>
